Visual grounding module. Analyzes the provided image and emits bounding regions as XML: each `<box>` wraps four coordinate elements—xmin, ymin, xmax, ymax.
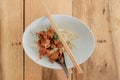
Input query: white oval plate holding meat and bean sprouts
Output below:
<box><xmin>23</xmin><ymin>15</ymin><xmax>95</xmax><ymax>69</ymax></box>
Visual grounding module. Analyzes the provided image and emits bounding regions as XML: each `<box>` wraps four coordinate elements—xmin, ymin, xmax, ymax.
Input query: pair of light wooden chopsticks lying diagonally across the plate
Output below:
<box><xmin>41</xmin><ymin>0</ymin><xmax>83</xmax><ymax>73</ymax></box>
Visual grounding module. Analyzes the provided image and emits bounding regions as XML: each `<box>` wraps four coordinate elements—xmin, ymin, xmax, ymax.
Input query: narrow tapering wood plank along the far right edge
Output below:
<box><xmin>109</xmin><ymin>0</ymin><xmax>120</xmax><ymax>79</ymax></box>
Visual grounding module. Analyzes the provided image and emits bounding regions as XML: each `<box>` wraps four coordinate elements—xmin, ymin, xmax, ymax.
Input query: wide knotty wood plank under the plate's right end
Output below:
<box><xmin>73</xmin><ymin>0</ymin><xmax>118</xmax><ymax>80</ymax></box>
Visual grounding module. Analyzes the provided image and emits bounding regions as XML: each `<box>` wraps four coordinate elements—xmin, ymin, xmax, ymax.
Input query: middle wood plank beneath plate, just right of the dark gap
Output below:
<box><xmin>25</xmin><ymin>0</ymin><xmax>72</xmax><ymax>80</ymax></box>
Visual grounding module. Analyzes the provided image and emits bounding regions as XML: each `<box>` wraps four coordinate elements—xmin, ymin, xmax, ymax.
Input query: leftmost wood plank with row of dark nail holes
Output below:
<box><xmin>0</xmin><ymin>0</ymin><xmax>23</xmax><ymax>80</ymax></box>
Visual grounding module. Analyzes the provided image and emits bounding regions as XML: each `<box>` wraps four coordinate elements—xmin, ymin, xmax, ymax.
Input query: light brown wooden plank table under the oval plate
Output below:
<box><xmin>0</xmin><ymin>0</ymin><xmax>120</xmax><ymax>80</ymax></box>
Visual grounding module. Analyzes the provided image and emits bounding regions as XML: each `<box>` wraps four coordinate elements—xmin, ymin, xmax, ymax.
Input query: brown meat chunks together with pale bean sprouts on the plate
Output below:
<box><xmin>36</xmin><ymin>27</ymin><xmax>78</xmax><ymax>63</ymax></box>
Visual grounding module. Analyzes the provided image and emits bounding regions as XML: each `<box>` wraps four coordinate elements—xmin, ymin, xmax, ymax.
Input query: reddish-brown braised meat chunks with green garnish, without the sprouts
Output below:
<box><xmin>36</xmin><ymin>28</ymin><xmax>64</xmax><ymax>63</ymax></box>
